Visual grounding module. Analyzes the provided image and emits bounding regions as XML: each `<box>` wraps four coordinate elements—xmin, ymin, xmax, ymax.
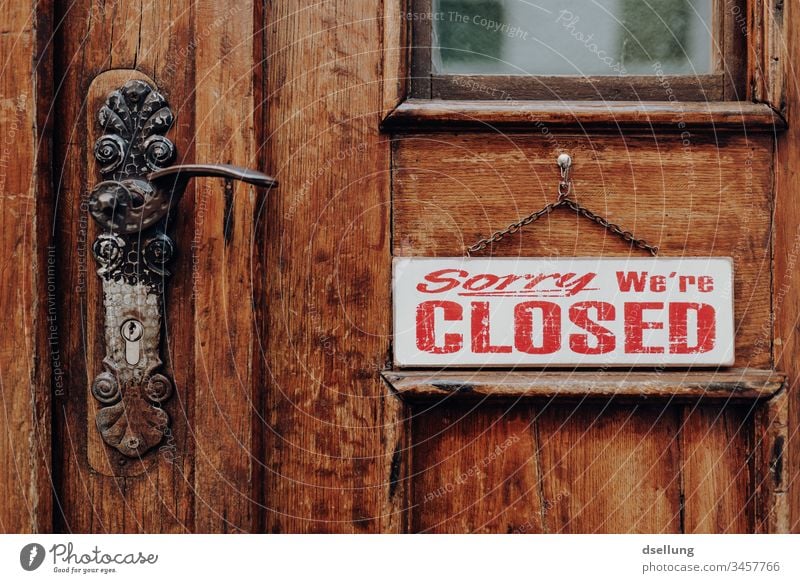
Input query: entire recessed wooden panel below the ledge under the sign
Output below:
<box><xmin>409</xmin><ymin>402</ymin><xmax>755</xmax><ymax>533</ymax></box>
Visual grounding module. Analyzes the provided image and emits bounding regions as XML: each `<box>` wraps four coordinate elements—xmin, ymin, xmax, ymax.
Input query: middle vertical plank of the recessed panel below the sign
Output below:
<box><xmin>539</xmin><ymin>403</ymin><xmax>681</xmax><ymax>533</ymax></box>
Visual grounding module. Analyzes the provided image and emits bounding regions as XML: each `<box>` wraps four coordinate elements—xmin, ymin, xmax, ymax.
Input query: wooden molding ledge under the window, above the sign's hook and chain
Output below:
<box><xmin>381</xmin><ymin>99</ymin><xmax>786</xmax><ymax>132</ymax></box>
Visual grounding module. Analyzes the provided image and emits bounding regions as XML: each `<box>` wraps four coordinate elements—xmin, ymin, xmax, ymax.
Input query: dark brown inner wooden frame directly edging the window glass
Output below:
<box><xmin>410</xmin><ymin>0</ymin><xmax>747</xmax><ymax>101</ymax></box>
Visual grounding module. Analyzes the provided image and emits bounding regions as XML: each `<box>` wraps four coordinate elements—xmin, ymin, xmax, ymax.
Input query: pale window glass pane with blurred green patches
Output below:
<box><xmin>431</xmin><ymin>0</ymin><xmax>713</xmax><ymax>76</ymax></box>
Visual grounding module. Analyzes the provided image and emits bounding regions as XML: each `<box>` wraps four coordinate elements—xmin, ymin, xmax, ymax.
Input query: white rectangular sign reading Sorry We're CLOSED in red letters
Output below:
<box><xmin>394</xmin><ymin>257</ymin><xmax>734</xmax><ymax>367</ymax></box>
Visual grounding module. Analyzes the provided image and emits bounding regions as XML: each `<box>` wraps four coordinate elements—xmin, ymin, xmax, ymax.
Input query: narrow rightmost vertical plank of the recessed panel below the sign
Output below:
<box><xmin>681</xmin><ymin>405</ymin><xmax>754</xmax><ymax>534</ymax></box>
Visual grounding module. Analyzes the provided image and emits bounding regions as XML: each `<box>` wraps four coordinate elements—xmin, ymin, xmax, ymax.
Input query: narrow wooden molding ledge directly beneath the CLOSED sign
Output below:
<box><xmin>382</xmin><ymin>368</ymin><xmax>786</xmax><ymax>402</ymax></box>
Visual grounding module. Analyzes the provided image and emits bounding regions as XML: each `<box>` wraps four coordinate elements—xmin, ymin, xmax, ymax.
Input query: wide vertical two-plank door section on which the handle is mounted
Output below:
<box><xmin>50</xmin><ymin>1</ymin><xmax>266</xmax><ymax>532</ymax></box>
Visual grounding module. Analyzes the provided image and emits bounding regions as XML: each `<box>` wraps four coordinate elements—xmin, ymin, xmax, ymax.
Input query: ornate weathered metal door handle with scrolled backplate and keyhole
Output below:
<box><xmin>88</xmin><ymin>80</ymin><xmax>277</xmax><ymax>457</ymax></box>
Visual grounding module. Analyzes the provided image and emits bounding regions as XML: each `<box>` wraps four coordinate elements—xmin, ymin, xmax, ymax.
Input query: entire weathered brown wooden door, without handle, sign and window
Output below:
<box><xmin>0</xmin><ymin>0</ymin><xmax>800</xmax><ymax>533</ymax></box>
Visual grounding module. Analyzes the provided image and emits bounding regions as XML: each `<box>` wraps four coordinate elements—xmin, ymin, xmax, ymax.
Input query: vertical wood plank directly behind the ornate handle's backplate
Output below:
<box><xmin>54</xmin><ymin>0</ymin><xmax>194</xmax><ymax>532</ymax></box>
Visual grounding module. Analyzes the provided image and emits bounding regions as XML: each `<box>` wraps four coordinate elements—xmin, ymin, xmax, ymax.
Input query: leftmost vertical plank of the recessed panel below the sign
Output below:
<box><xmin>411</xmin><ymin>403</ymin><xmax>544</xmax><ymax>534</ymax></box>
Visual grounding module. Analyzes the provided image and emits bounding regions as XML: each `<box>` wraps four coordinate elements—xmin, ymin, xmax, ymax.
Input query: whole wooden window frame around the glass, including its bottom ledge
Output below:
<box><xmin>381</xmin><ymin>0</ymin><xmax>788</xmax><ymax>132</ymax></box>
